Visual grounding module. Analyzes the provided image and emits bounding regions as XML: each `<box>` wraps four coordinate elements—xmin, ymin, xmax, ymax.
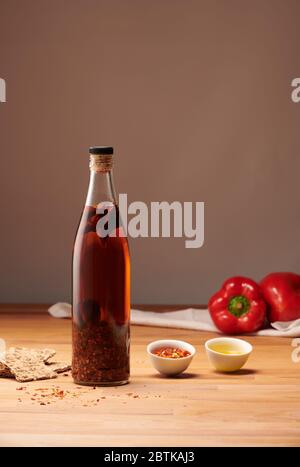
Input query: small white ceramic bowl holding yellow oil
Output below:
<box><xmin>205</xmin><ymin>337</ymin><xmax>252</xmax><ymax>372</ymax></box>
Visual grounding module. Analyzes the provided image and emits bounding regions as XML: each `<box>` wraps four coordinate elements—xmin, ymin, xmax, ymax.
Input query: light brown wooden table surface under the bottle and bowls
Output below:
<box><xmin>0</xmin><ymin>306</ymin><xmax>300</xmax><ymax>446</ymax></box>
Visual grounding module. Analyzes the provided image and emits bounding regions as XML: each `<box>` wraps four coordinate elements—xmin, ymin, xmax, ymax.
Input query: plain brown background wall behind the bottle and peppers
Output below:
<box><xmin>0</xmin><ymin>0</ymin><xmax>300</xmax><ymax>303</ymax></box>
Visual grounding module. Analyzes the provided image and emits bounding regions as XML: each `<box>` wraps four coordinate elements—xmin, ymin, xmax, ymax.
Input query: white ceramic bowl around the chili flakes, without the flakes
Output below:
<box><xmin>147</xmin><ymin>339</ymin><xmax>196</xmax><ymax>376</ymax></box>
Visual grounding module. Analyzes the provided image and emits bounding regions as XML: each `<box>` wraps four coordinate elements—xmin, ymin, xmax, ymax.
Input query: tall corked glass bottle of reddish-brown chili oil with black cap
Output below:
<box><xmin>72</xmin><ymin>146</ymin><xmax>130</xmax><ymax>386</ymax></box>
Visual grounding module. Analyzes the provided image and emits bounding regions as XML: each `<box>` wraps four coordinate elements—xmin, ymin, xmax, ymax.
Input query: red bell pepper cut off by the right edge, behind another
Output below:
<box><xmin>260</xmin><ymin>272</ymin><xmax>300</xmax><ymax>323</ymax></box>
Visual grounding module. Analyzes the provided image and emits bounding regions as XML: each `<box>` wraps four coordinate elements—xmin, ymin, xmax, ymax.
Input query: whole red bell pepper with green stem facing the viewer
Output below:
<box><xmin>208</xmin><ymin>277</ymin><xmax>266</xmax><ymax>334</ymax></box>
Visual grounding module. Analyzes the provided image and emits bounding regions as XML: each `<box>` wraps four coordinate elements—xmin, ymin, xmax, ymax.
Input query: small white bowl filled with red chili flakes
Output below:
<box><xmin>147</xmin><ymin>340</ymin><xmax>196</xmax><ymax>376</ymax></box>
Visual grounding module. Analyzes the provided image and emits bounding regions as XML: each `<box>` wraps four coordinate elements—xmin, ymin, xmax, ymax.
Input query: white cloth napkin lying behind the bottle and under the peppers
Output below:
<box><xmin>48</xmin><ymin>303</ymin><xmax>300</xmax><ymax>337</ymax></box>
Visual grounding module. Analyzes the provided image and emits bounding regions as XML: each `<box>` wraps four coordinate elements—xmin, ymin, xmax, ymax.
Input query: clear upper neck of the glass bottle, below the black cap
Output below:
<box><xmin>85</xmin><ymin>155</ymin><xmax>117</xmax><ymax>206</ymax></box>
